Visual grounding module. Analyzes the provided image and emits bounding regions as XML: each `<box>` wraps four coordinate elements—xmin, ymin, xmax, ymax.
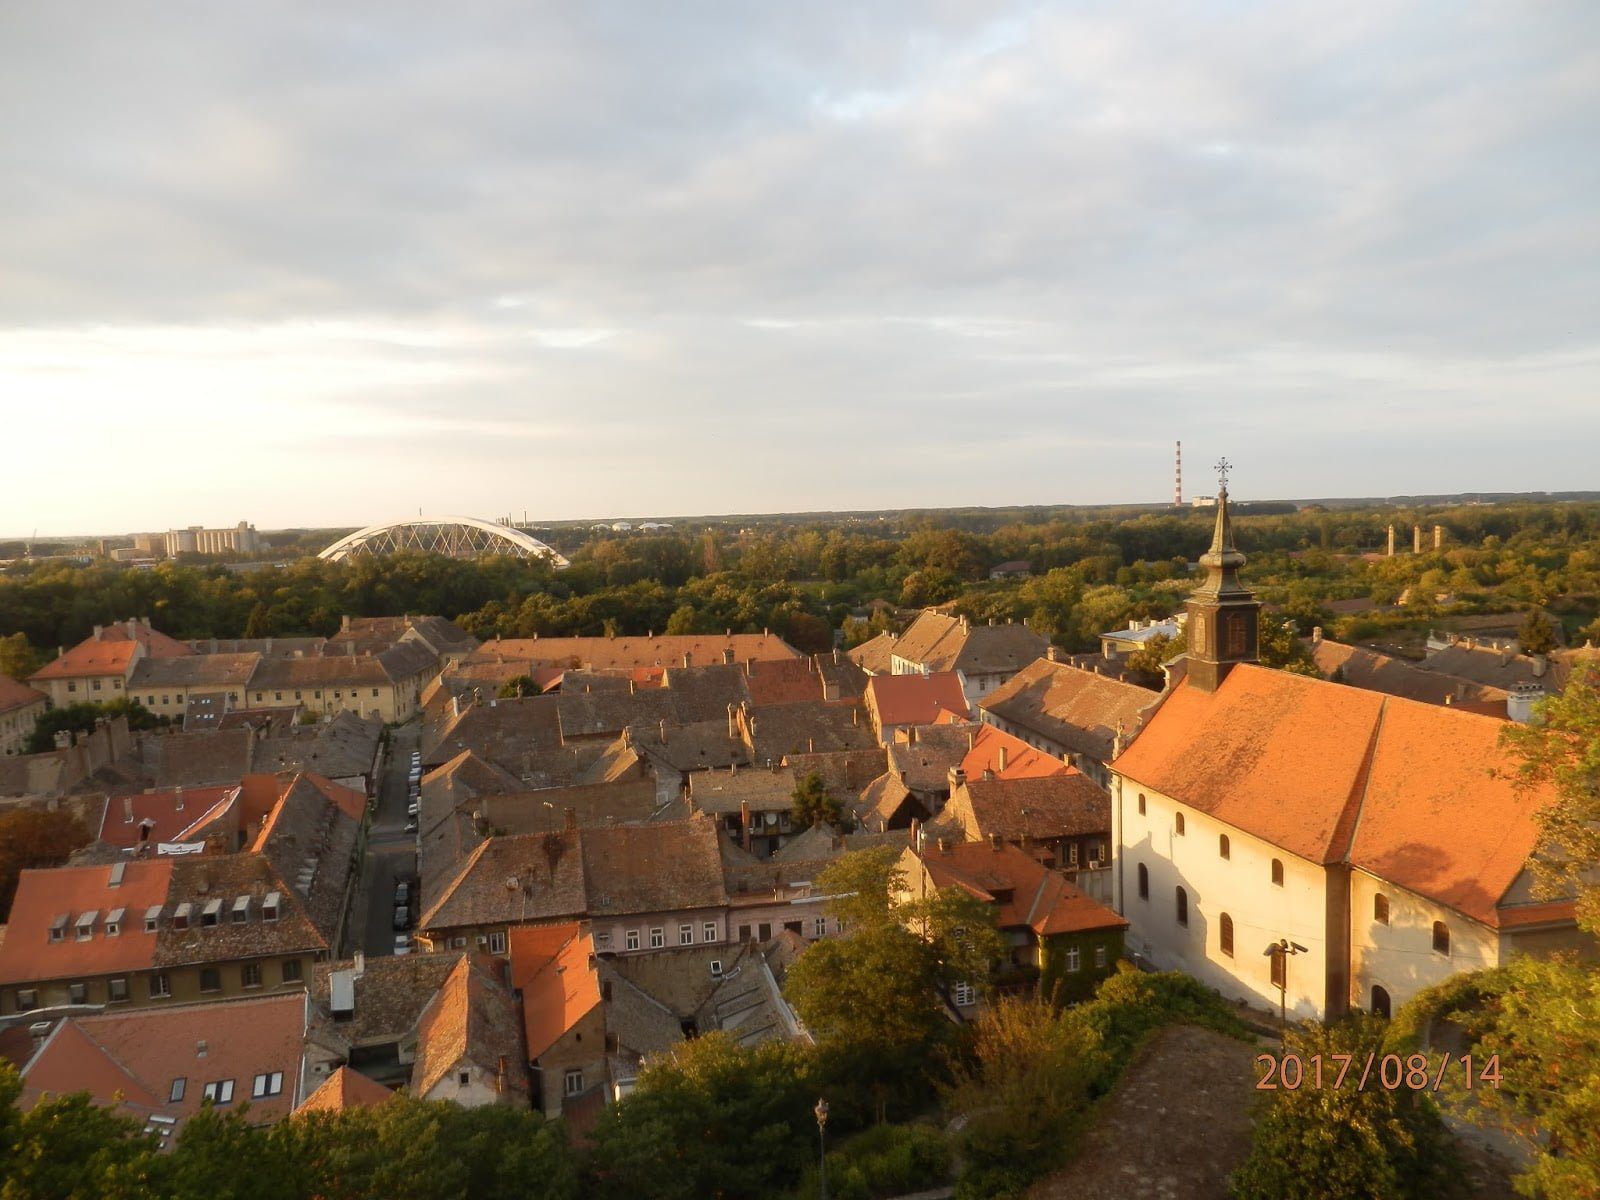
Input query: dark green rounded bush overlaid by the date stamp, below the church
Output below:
<box><xmin>1230</xmin><ymin>1016</ymin><xmax>1459</xmax><ymax>1200</ymax></box>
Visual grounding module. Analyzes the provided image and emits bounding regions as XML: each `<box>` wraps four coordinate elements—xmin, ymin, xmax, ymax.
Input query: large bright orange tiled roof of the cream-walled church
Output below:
<box><xmin>1115</xmin><ymin>666</ymin><xmax>1552</xmax><ymax>923</ymax></box>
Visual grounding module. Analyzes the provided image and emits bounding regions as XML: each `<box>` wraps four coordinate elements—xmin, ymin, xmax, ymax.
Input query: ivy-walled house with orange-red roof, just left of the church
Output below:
<box><xmin>896</xmin><ymin>838</ymin><xmax>1128</xmax><ymax>1016</ymax></box>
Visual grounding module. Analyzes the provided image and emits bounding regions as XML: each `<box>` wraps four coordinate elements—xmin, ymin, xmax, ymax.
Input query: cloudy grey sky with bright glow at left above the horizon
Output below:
<box><xmin>0</xmin><ymin>0</ymin><xmax>1600</xmax><ymax>533</ymax></box>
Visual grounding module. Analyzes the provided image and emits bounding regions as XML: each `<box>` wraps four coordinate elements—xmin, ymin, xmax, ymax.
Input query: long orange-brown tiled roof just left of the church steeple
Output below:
<box><xmin>978</xmin><ymin>658</ymin><xmax>1160</xmax><ymax>762</ymax></box>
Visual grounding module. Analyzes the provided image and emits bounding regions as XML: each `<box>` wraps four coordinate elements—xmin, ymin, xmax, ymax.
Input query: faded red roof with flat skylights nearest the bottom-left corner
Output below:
<box><xmin>21</xmin><ymin>989</ymin><xmax>307</xmax><ymax>1147</ymax></box>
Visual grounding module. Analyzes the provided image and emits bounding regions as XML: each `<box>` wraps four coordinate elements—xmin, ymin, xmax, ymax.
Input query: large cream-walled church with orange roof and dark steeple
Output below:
<box><xmin>1110</xmin><ymin>480</ymin><xmax>1594</xmax><ymax>1019</ymax></box>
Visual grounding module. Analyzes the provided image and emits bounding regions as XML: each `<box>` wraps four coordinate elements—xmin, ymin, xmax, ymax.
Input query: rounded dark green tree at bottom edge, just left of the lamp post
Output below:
<box><xmin>594</xmin><ymin>1034</ymin><xmax>816</xmax><ymax>1200</ymax></box>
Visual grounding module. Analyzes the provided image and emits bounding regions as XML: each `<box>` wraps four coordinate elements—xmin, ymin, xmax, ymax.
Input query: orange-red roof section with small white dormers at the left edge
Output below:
<box><xmin>0</xmin><ymin>859</ymin><xmax>173</xmax><ymax>984</ymax></box>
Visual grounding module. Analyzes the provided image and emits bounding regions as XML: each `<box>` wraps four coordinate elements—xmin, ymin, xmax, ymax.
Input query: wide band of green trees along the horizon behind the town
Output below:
<box><xmin>0</xmin><ymin>504</ymin><xmax>1600</xmax><ymax>667</ymax></box>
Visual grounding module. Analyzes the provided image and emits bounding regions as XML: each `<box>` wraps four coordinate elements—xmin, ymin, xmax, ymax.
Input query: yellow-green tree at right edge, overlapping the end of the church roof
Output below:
<box><xmin>1501</xmin><ymin>662</ymin><xmax>1600</xmax><ymax>933</ymax></box>
